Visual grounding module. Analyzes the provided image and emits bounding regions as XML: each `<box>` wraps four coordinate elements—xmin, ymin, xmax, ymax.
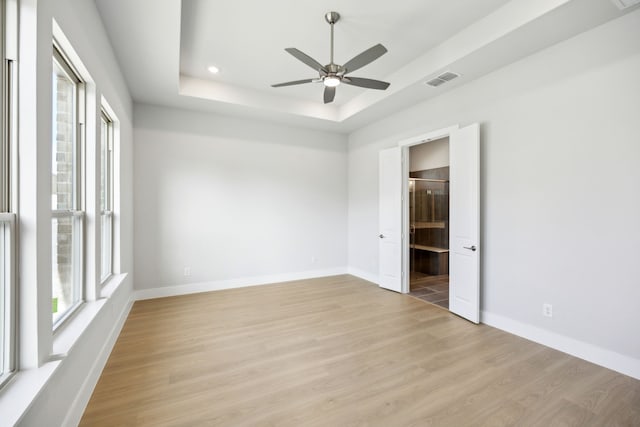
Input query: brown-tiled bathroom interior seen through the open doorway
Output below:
<box><xmin>409</xmin><ymin>137</ymin><xmax>449</xmax><ymax>310</ymax></box>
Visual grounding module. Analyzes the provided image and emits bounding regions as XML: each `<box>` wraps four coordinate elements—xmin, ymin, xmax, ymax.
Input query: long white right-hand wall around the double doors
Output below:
<box><xmin>349</xmin><ymin>11</ymin><xmax>640</xmax><ymax>378</ymax></box>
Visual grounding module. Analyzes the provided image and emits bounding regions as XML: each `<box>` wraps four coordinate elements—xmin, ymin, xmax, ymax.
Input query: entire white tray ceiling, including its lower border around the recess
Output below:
<box><xmin>95</xmin><ymin>0</ymin><xmax>629</xmax><ymax>132</ymax></box>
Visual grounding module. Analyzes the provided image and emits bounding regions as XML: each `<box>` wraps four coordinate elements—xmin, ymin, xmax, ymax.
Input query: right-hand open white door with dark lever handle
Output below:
<box><xmin>449</xmin><ymin>123</ymin><xmax>480</xmax><ymax>323</ymax></box>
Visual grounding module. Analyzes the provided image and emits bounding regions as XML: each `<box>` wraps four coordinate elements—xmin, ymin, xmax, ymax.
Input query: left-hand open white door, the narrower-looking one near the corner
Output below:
<box><xmin>378</xmin><ymin>147</ymin><xmax>402</xmax><ymax>292</ymax></box>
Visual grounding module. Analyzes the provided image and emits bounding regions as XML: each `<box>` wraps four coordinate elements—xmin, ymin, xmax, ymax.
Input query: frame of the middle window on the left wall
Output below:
<box><xmin>51</xmin><ymin>43</ymin><xmax>86</xmax><ymax>332</ymax></box>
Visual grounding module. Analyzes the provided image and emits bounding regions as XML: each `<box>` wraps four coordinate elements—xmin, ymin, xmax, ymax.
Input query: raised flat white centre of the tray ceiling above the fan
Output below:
<box><xmin>180</xmin><ymin>0</ymin><xmax>508</xmax><ymax>105</ymax></box>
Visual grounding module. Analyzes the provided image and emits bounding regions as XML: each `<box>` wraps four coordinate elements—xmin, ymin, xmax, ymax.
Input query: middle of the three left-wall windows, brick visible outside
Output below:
<box><xmin>51</xmin><ymin>48</ymin><xmax>84</xmax><ymax>327</ymax></box>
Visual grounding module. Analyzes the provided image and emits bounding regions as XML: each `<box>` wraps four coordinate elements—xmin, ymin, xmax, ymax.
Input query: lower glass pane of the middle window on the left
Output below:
<box><xmin>51</xmin><ymin>216</ymin><xmax>80</xmax><ymax>324</ymax></box>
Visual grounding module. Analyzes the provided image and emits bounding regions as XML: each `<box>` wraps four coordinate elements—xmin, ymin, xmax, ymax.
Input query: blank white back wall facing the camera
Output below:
<box><xmin>134</xmin><ymin>104</ymin><xmax>347</xmax><ymax>292</ymax></box>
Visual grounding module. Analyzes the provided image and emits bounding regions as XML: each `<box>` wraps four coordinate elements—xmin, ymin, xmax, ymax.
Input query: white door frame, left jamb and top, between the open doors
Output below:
<box><xmin>398</xmin><ymin>125</ymin><xmax>460</xmax><ymax>294</ymax></box>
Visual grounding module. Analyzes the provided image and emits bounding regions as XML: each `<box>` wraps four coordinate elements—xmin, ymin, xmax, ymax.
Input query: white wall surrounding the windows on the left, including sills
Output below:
<box><xmin>9</xmin><ymin>0</ymin><xmax>133</xmax><ymax>426</ymax></box>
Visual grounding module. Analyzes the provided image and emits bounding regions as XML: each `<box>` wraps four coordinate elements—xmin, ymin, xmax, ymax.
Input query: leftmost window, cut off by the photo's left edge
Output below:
<box><xmin>0</xmin><ymin>0</ymin><xmax>17</xmax><ymax>386</ymax></box>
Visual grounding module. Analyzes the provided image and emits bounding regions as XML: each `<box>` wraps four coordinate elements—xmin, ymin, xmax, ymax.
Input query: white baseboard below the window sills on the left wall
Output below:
<box><xmin>63</xmin><ymin>293</ymin><xmax>135</xmax><ymax>427</ymax></box>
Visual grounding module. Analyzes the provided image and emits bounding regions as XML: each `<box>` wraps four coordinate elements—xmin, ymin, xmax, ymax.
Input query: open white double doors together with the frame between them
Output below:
<box><xmin>378</xmin><ymin>123</ymin><xmax>481</xmax><ymax>323</ymax></box>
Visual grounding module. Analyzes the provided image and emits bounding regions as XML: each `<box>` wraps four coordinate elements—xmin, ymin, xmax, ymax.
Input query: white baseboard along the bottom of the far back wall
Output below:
<box><xmin>135</xmin><ymin>267</ymin><xmax>347</xmax><ymax>300</ymax></box>
